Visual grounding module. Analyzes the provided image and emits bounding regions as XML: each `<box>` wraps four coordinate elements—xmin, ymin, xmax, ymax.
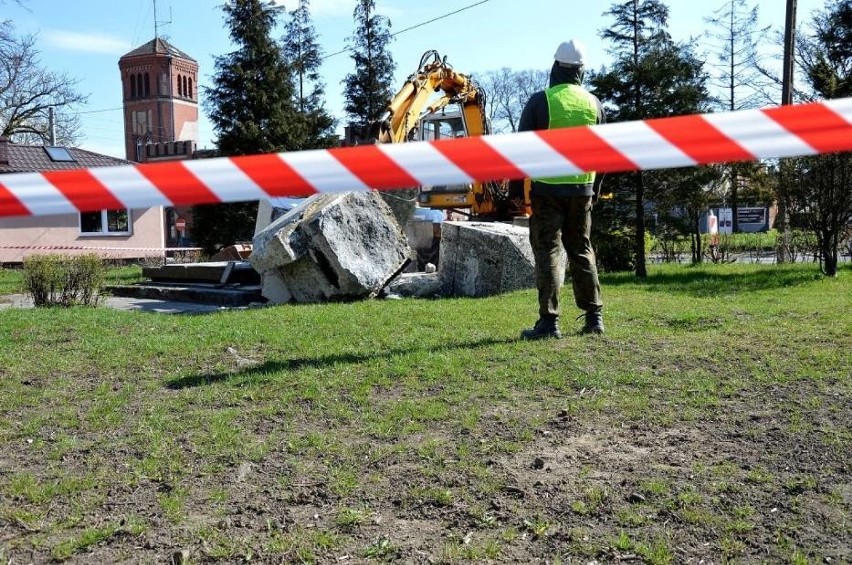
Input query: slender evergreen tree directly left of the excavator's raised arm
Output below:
<box><xmin>343</xmin><ymin>0</ymin><xmax>396</xmax><ymax>138</ymax></box>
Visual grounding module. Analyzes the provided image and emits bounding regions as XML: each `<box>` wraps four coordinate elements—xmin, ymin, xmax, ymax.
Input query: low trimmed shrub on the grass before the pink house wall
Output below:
<box><xmin>24</xmin><ymin>254</ymin><xmax>106</xmax><ymax>307</ymax></box>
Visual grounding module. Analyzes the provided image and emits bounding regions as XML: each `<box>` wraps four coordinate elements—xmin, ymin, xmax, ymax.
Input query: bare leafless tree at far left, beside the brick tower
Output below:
<box><xmin>0</xmin><ymin>21</ymin><xmax>87</xmax><ymax>145</ymax></box>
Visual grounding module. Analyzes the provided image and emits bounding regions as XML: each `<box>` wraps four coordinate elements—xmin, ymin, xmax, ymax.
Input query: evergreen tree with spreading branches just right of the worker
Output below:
<box><xmin>591</xmin><ymin>0</ymin><xmax>710</xmax><ymax>278</ymax></box>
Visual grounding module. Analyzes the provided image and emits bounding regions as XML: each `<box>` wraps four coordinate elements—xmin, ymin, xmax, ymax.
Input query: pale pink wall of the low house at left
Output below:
<box><xmin>0</xmin><ymin>206</ymin><xmax>165</xmax><ymax>264</ymax></box>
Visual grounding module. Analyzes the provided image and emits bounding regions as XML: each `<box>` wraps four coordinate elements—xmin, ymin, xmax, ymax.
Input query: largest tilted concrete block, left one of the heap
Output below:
<box><xmin>250</xmin><ymin>192</ymin><xmax>409</xmax><ymax>302</ymax></box>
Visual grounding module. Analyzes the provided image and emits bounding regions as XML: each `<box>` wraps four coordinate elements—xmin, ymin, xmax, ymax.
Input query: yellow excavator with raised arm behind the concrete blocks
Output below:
<box><xmin>374</xmin><ymin>50</ymin><xmax>529</xmax><ymax>221</ymax></box>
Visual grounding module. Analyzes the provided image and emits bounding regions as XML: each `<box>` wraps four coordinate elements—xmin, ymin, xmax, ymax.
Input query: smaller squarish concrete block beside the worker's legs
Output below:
<box><xmin>438</xmin><ymin>222</ymin><xmax>535</xmax><ymax>296</ymax></box>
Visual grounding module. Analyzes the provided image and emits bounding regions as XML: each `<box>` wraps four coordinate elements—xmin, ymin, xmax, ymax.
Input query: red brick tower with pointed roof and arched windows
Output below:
<box><xmin>118</xmin><ymin>37</ymin><xmax>198</xmax><ymax>162</ymax></box>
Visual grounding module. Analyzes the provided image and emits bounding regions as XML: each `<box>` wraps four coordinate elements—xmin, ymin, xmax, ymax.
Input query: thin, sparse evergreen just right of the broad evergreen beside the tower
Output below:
<box><xmin>282</xmin><ymin>0</ymin><xmax>337</xmax><ymax>149</ymax></box>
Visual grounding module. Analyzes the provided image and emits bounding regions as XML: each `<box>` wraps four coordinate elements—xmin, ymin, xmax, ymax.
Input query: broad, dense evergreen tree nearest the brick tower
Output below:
<box><xmin>193</xmin><ymin>0</ymin><xmax>305</xmax><ymax>253</ymax></box>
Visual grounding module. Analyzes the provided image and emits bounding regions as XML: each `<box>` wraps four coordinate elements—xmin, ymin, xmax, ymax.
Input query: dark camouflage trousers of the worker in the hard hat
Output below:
<box><xmin>530</xmin><ymin>196</ymin><xmax>603</xmax><ymax>318</ymax></box>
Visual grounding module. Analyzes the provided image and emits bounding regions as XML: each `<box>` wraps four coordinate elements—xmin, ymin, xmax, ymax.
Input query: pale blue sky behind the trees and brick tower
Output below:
<box><xmin>0</xmin><ymin>0</ymin><xmax>830</xmax><ymax>158</ymax></box>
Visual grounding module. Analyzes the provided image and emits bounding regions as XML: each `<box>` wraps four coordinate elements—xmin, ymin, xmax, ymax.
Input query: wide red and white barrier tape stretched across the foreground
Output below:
<box><xmin>0</xmin><ymin>98</ymin><xmax>852</xmax><ymax>217</ymax></box>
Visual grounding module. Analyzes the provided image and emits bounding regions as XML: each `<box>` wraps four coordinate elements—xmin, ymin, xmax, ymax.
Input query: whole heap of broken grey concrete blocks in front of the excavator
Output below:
<box><xmin>249</xmin><ymin>192</ymin><xmax>535</xmax><ymax>304</ymax></box>
